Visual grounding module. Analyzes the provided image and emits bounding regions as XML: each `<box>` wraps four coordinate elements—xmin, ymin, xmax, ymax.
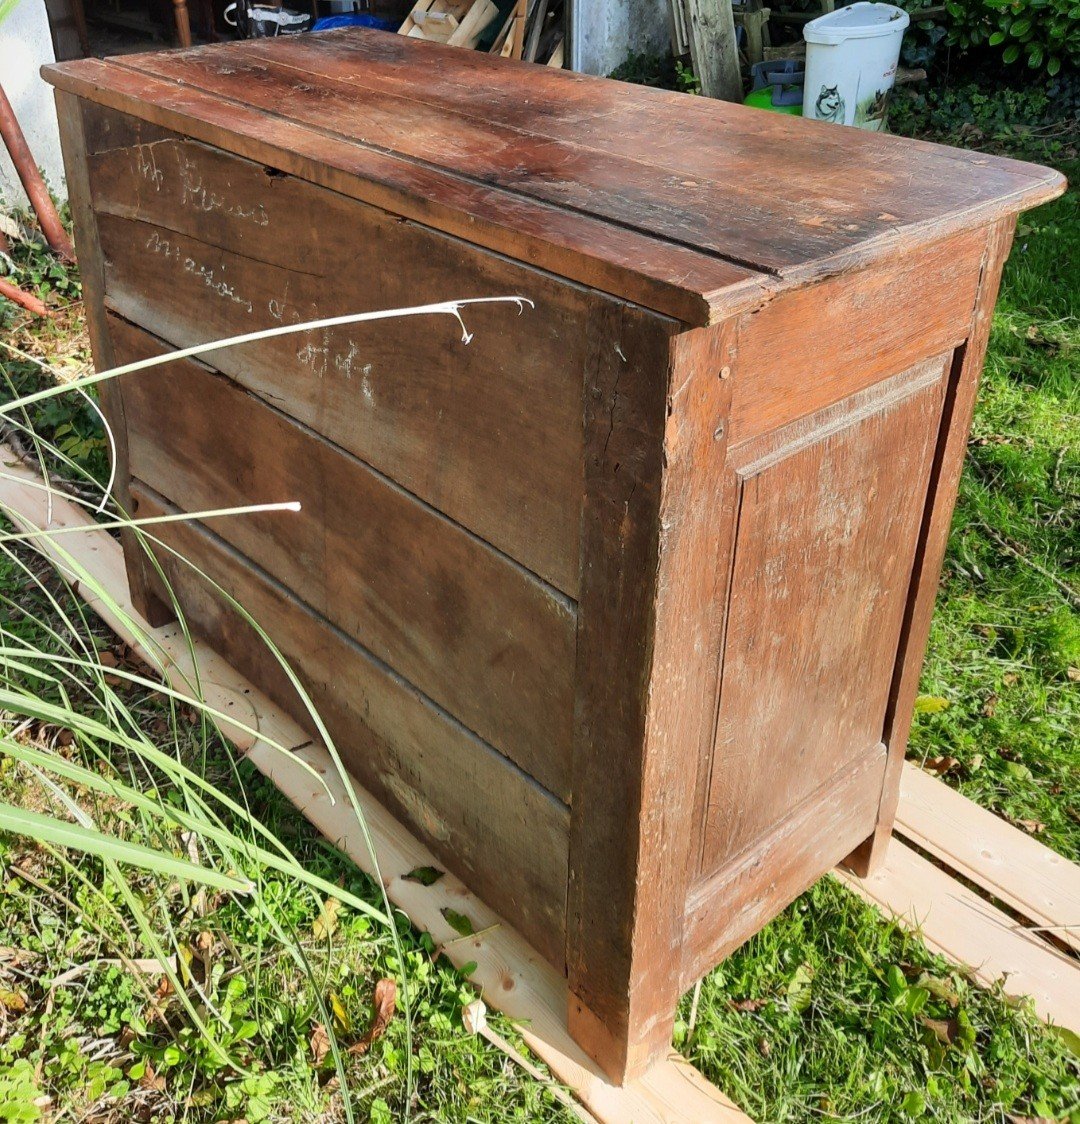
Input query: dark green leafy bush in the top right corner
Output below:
<box><xmin>945</xmin><ymin>0</ymin><xmax>1080</xmax><ymax>78</ymax></box>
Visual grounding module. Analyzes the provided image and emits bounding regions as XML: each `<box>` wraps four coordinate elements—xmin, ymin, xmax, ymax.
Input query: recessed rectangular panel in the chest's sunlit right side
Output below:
<box><xmin>701</xmin><ymin>356</ymin><xmax>947</xmax><ymax>872</ymax></box>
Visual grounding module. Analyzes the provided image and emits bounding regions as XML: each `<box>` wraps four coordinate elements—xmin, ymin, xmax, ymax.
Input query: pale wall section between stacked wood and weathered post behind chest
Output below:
<box><xmin>571</xmin><ymin>0</ymin><xmax>671</xmax><ymax>74</ymax></box>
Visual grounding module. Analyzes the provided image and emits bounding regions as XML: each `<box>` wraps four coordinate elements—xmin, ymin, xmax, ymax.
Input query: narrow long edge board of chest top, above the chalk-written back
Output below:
<box><xmin>46</xmin><ymin>59</ymin><xmax>769</xmax><ymax>324</ymax></box>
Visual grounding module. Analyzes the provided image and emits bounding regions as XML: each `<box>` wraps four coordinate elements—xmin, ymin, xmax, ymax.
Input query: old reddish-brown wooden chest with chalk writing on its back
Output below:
<box><xmin>45</xmin><ymin>30</ymin><xmax>1062</xmax><ymax>1080</ymax></box>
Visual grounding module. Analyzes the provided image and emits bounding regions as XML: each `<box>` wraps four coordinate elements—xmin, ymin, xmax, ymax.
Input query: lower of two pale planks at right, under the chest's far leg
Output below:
<box><xmin>840</xmin><ymin>840</ymin><xmax>1080</xmax><ymax>1032</ymax></box>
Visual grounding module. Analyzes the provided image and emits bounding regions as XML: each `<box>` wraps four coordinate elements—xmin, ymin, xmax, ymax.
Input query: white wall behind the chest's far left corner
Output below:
<box><xmin>0</xmin><ymin>0</ymin><xmax>67</xmax><ymax>210</ymax></box>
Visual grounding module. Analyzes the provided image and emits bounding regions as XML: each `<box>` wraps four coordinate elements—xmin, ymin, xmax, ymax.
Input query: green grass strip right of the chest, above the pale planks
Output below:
<box><xmin>910</xmin><ymin>163</ymin><xmax>1080</xmax><ymax>861</ymax></box>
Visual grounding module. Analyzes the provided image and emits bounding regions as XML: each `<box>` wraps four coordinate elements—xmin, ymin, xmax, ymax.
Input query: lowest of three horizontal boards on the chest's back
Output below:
<box><xmin>133</xmin><ymin>480</ymin><xmax>569</xmax><ymax>968</ymax></box>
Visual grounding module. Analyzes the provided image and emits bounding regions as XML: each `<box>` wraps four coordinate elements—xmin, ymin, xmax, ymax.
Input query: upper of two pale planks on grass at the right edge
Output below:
<box><xmin>896</xmin><ymin>762</ymin><xmax>1080</xmax><ymax>952</ymax></box>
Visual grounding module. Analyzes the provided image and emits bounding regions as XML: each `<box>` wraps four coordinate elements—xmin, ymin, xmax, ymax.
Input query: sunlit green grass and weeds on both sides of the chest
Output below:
<box><xmin>0</xmin><ymin>103</ymin><xmax>1080</xmax><ymax>1124</ymax></box>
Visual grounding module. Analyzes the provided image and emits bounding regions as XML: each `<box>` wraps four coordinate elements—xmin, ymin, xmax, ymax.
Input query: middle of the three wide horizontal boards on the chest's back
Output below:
<box><xmin>109</xmin><ymin>317</ymin><xmax>577</xmax><ymax>801</ymax></box>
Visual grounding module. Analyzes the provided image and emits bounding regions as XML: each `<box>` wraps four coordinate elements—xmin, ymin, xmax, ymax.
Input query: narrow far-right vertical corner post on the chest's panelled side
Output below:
<box><xmin>848</xmin><ymin>218</ymin><xmax>1016</xmax><ymax>876</ymax></box>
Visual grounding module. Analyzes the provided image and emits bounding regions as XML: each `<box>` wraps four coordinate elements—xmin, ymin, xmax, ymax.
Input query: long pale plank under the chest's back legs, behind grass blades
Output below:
<box><xmin>0</xmin><ymin>446</ymin><xmax>748</xmax><ymax>1124</ymax></box>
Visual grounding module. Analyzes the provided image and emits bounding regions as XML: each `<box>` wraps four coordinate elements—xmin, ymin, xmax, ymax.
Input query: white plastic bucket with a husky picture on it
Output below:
<box><xmin>802</xmin><ymin>2</ymin><xmax>910</xmax><ymax>132</ymax></box>
